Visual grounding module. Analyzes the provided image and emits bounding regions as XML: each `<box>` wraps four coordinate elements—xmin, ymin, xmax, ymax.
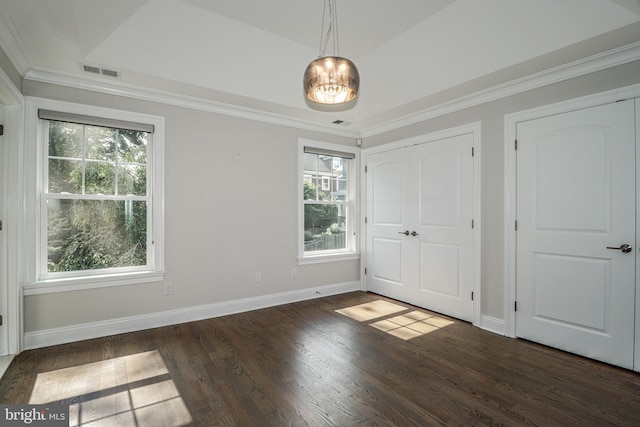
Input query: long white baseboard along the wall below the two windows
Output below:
<box><xmin>24</xmin><ymin>281</ymin><xmax>362</xmax><ymax>350</ymax></box>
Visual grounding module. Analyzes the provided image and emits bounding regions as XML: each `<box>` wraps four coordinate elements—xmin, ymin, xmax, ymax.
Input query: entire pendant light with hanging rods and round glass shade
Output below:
<box><xmin>303</xmin><ymin>0</ymin><xmax>360</xmax><ymax>105</ymax></box>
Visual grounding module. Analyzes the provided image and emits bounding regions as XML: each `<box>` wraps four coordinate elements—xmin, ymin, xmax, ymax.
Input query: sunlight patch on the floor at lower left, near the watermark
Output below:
<box><xmin>29</xmin><ymin>350</ymin><xmax>193</xmax><ymax>427</ymax></box>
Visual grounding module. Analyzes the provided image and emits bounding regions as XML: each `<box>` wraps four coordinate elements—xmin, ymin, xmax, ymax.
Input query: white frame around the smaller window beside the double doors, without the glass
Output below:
<box><xmin>298</xmin><ymin>139</ymin><xmax>360</xmax><ymax>265</ymax></box>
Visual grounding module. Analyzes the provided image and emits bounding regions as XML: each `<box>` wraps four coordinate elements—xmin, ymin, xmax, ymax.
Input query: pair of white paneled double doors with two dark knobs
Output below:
<box><xmin>366</xmin><ymin>134</ymin><xmax>474</xmax><ymax>321</ymax></box>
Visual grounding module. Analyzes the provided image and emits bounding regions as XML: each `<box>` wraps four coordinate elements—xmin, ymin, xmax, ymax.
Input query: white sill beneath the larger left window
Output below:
<box><xmin>23</xmin><ymin>271</ymin><xmax>164</xmax><ymax>296</ymax></box>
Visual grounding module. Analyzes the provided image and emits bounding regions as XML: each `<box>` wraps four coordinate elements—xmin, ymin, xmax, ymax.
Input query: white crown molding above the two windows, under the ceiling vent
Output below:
<box><xmin>24</xmin><ymin>67</ymin><xmax>360</xmax><ymax>138</ymax></box>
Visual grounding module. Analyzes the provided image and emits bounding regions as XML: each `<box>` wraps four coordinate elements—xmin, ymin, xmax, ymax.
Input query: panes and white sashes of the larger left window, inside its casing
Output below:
<box><xmin>40</xmin><ymin>120</ymin><xmax>153</xmax><ymax>278</ymax></box>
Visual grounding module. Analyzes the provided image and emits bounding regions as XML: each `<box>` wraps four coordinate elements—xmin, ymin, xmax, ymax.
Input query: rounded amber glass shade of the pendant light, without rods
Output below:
<box><xmin>304</xmin><ymin>56</ymin><xmax>360</xmax><ymax>104</ymax></box>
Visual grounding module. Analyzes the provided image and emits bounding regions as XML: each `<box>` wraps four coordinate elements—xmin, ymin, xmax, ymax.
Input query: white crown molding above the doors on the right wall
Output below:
<box><xmin>361</xmin><ymin>42</ymin><xmax>640</xmax><ymax>138</ymax></box>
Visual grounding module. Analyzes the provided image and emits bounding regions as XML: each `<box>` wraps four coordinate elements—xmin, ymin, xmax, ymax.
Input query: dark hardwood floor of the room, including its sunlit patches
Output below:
<box><xmin>0</xmin><ymin>292</ymin><xmax>640</xmax><ymax>427</ymax></box>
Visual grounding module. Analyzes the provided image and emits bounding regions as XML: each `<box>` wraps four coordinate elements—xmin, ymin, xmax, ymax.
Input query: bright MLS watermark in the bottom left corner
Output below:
<box><xmin>0</xmin><ymin>405</ymin><xmax>69</xmax><ymax>427</ymax></box>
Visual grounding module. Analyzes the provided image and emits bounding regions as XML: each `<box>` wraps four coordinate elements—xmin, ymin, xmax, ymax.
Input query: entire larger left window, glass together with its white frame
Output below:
<box><xmin>25</xmin><ymin>100</ymin><xmax>164</xmax><ymax>294</ymax></box>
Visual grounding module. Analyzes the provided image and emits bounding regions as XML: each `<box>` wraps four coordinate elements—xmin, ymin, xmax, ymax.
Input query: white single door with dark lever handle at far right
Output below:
<box><xmin>516</xmin><ymin>101</ymin><xmax>636</xmax><ymax>368</ymax></box>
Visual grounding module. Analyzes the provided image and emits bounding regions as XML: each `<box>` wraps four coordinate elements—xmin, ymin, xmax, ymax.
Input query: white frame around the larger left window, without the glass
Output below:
<box><xmin>23</xmin><ymin>97</ymin><xmax>165</xmax><ymax>295</ymax></box>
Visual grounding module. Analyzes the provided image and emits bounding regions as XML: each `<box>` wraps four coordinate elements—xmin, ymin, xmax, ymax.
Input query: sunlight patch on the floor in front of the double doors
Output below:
<box><xmin>336</xmin><ymin>300</ymin><xmax>455</xmax><ymax>341</ymax></box>
